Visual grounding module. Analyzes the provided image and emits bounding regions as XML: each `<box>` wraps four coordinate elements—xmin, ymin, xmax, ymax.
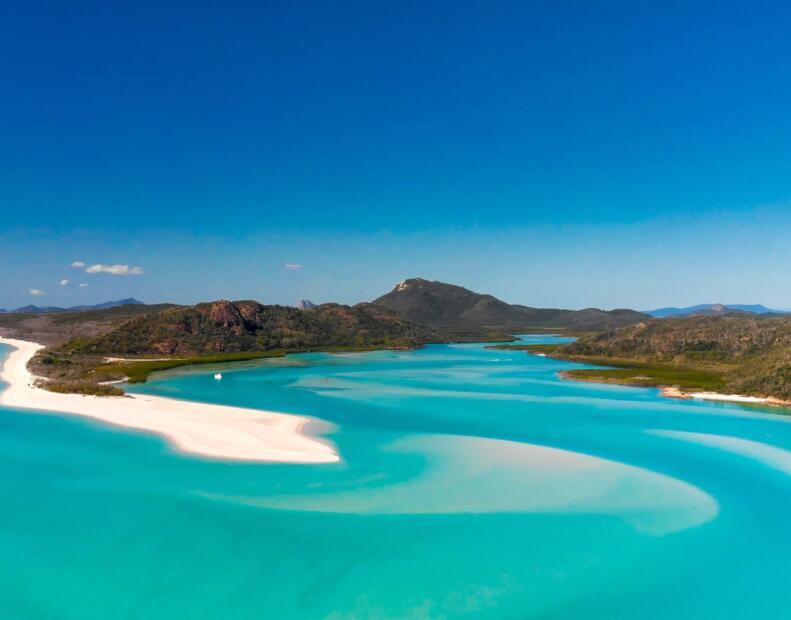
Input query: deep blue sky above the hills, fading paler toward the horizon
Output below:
<box><xmin>0</xmin><ymin>2</ymin><xmax>791</xmax><ymax>308</ymax></box>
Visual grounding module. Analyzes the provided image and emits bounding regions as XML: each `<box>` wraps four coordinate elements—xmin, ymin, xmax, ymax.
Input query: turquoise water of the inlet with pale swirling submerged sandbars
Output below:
<box><xmin>0</xmin><ymin>336</ymin><xmax>791</xmax><ymax>620</ymax></box>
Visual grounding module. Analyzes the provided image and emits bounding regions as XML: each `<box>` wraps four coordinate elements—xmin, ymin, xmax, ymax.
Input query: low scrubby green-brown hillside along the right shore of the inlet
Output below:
<box><xmin>555</xmin><ymin>314</ymin><xmax>791</xmax><ymax>400</ymax></box>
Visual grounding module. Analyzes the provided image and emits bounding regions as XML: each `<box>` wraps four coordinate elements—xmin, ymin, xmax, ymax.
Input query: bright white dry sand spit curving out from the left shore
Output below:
<box><xmin>0</xmin><ymin>337</ymin><xmax>340</xmax><ymax>463</ymax></box>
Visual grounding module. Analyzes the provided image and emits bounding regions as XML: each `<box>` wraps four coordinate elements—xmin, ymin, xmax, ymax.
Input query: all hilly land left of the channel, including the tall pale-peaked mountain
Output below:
<box><xmin>0</xmin><ymin>280</ymin><xmax>656</xmax><ymax>394</ymax></box>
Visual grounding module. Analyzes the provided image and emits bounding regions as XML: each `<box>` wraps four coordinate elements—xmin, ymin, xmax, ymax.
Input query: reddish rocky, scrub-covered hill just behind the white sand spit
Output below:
<box><xmin>16</xmin><ymin>301</ymin><xmax>437</xmax><ymax>395</ymax></box>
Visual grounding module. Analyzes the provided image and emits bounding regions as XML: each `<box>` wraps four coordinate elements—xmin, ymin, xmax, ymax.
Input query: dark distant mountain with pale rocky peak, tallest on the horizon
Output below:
<box><xmin>373</xmin><ymin>278</ymin><xmax>650</xmax><ymax>331</ymax></box>
